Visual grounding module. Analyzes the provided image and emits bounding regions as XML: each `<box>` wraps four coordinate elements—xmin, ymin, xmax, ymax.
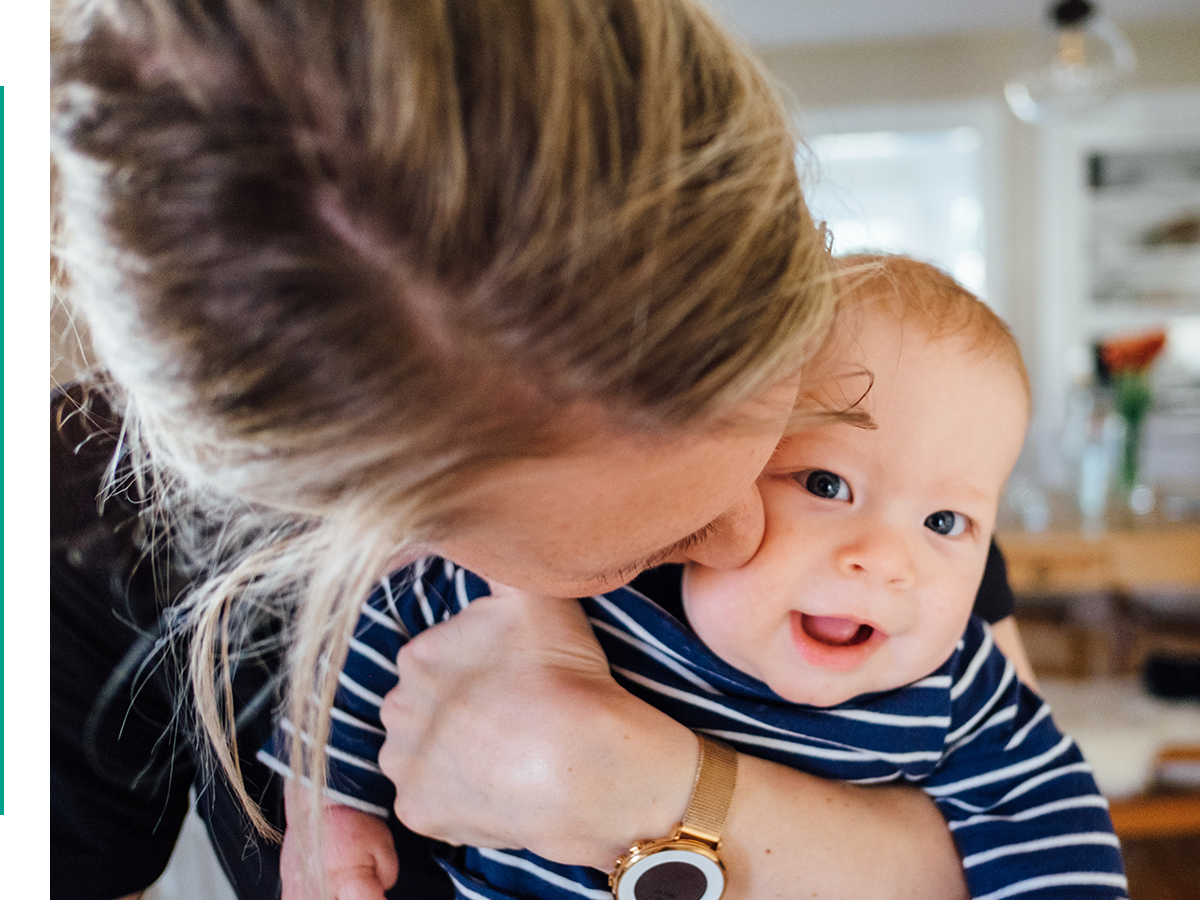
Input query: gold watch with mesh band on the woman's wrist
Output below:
<box><xmin>608</xmin><ymin>733</ymin><xmax>738</xmax><ymax>900</ymax></box>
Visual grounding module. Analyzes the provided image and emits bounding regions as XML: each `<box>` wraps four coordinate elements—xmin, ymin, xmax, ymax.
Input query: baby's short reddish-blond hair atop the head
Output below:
<box><xmin>792</xmin><ymin>253</ymin><xmax>1032</xmax><ymax>428</ymax></box>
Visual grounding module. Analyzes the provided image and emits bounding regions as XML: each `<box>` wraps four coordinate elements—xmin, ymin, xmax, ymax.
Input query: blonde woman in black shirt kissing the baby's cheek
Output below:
<box><xmin>50</xmin><ymin>0</ymin><xmax>1027</xmax><ymax>898</ymax></box>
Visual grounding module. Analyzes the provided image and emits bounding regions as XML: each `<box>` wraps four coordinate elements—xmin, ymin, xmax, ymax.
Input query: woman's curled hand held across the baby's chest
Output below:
<box><xmin>379</xmin><ymin>588</ymin><xmax>697</xmax><ymax>869</ymax></box>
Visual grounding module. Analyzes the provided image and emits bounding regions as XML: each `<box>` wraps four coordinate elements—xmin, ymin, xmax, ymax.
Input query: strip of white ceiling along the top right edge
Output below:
<box><xmin>704</xmin><ymin>0</ymin><xmax>1200</xmax><ymax>52</ymax></box>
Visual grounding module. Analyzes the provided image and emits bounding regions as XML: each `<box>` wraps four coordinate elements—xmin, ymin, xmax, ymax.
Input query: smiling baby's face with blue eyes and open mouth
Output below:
<box><xmin>684</xmin><ymin>316</ymin><xmax>1028</xmax><ymax>707</ymax></box>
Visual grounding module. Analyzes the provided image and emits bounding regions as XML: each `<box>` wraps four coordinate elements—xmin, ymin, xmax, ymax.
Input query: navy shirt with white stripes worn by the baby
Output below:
<box><xmin>259</xmin><ymin>558</ymin><xmax>1127</xmax><ymax>900</ymax></box>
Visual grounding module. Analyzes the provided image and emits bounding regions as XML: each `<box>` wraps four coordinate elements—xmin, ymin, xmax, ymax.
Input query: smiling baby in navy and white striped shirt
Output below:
<box><xmin>260</xmin><ymin>257</ymin><xmax>1126</xmax><ymax>900</ymax></box>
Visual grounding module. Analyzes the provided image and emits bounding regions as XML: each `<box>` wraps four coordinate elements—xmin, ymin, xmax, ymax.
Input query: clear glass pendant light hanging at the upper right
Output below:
<box><xmin>1004</xmin><ymin>0</ymin><xmax>1136</xmax><ymax>125</ymax></box>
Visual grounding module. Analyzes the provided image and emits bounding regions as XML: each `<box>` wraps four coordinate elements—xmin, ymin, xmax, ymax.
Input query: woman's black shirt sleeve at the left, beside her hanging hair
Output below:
<box><xmin>47</xmin><ymin>388</ymin><xmax>196</xmax><ymax>900</ymax></box>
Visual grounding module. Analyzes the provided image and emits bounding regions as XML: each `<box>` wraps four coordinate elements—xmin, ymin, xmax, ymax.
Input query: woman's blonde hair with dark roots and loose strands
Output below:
<box><xmin>49</xmin><ymin>0</ymin><xmax>832</xmax><ymax>873</ymax></box>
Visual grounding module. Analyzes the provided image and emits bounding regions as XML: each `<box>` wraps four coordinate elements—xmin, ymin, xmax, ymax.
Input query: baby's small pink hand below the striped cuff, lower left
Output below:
<box><xmin>280</xmin><ymin>805</ymin><xmax>400</xmax><ymax>900</ymax></box>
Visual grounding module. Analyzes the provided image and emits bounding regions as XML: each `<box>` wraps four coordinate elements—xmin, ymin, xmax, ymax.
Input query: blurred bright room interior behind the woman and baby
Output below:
<box><xmin>49</xmin><ymin>0</ymin><xmax>1200</xmax><ymax>900</ymax></box>
